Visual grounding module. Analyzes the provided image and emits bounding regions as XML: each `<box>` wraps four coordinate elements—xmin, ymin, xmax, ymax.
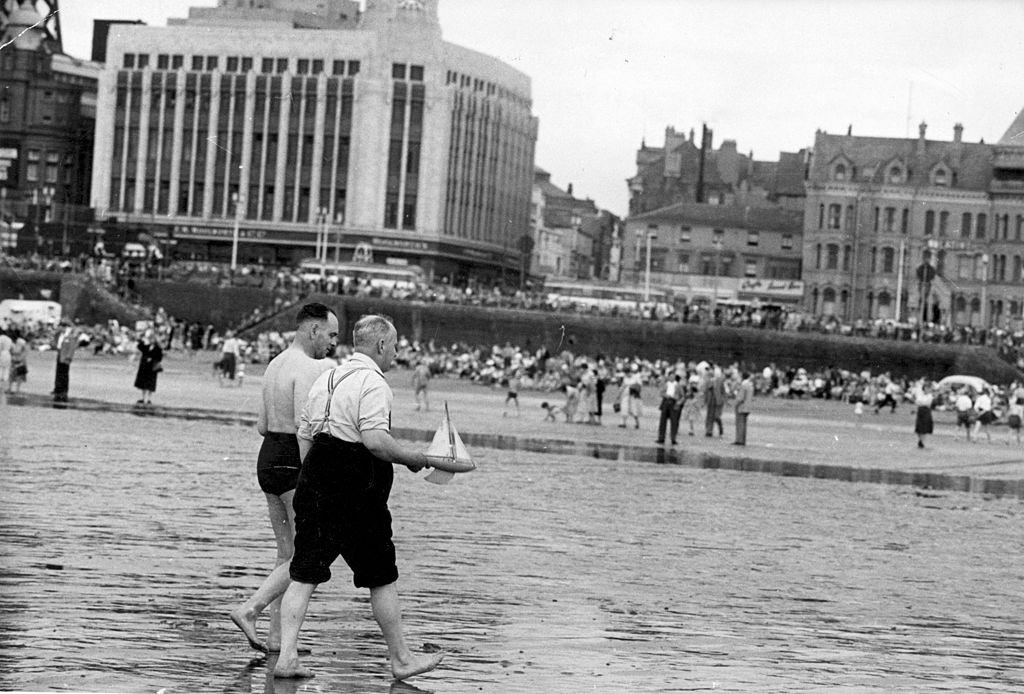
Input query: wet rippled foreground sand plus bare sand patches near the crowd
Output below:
<box><xmin>0</xmin><ymin>359</ymin><xmax>1024</xmax><ymax>693</ymax></box>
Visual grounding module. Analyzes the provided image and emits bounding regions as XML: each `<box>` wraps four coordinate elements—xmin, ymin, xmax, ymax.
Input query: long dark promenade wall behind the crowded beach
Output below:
<box><xmin>0</xmin><ymin>270</ymin><xmax>1020</xmax><ymax>383</ymax></box>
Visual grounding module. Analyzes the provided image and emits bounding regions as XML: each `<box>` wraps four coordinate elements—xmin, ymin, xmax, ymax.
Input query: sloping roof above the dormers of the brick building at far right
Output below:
<box><xmin>808</xmin><ymin>131</ymin><xmax>992</xmax><ymax>190</ymax></box>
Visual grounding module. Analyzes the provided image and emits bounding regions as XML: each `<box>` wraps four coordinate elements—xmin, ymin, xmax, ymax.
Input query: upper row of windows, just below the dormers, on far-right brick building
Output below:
<box><xmin>818</xmin><ymin>203</ymin><xmax>1024</xmax><ymax>241</ymax></box>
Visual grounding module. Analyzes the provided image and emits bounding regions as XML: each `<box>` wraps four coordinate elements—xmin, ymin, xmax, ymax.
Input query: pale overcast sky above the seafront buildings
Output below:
<box><xmin>59</xmin><ymin>0</ymin><xmax>1024</xmax><ymax>215</ymax></box>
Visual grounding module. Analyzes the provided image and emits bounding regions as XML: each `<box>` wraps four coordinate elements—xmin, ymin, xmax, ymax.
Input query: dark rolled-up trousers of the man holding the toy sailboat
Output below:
<box><xmin>290</xmin><ymin>434</ymin><xmax>398</xmax><ymax>588</ymax></box>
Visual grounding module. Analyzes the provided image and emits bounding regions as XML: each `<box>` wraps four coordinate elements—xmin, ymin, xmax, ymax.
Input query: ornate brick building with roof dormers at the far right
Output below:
<box><xmin>803</xmin><ymin>118</ymin><xmax>1024</xmax><ymax>326</ymax></box>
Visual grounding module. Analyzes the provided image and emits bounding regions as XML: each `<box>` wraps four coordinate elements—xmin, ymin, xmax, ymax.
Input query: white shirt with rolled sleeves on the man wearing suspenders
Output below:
<box><xmin>297</xmin><ymin>352</ymin><xmax>394</xmax><ymax>443</ymax></box>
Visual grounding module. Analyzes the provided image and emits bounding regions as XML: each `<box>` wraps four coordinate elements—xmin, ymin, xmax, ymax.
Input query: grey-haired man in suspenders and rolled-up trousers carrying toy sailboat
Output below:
<box><xmin>273</xmin><ymin>315</ymin><xmax>443</xmax><ymax>680</ymax></box>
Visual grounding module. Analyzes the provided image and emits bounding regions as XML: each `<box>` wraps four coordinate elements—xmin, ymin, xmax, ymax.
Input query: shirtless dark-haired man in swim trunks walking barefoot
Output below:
<box><xmin>231</xmin><ymin>303</ymin><xmax>338</xmax><ymax>652</ymax></box>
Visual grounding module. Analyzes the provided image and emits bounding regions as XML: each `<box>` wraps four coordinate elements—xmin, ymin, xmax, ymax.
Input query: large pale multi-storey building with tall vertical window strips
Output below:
<box><xmin>91</xmin><ymin>0</ymin><xmax>537</xmax><ymax>281</ymax></box>
